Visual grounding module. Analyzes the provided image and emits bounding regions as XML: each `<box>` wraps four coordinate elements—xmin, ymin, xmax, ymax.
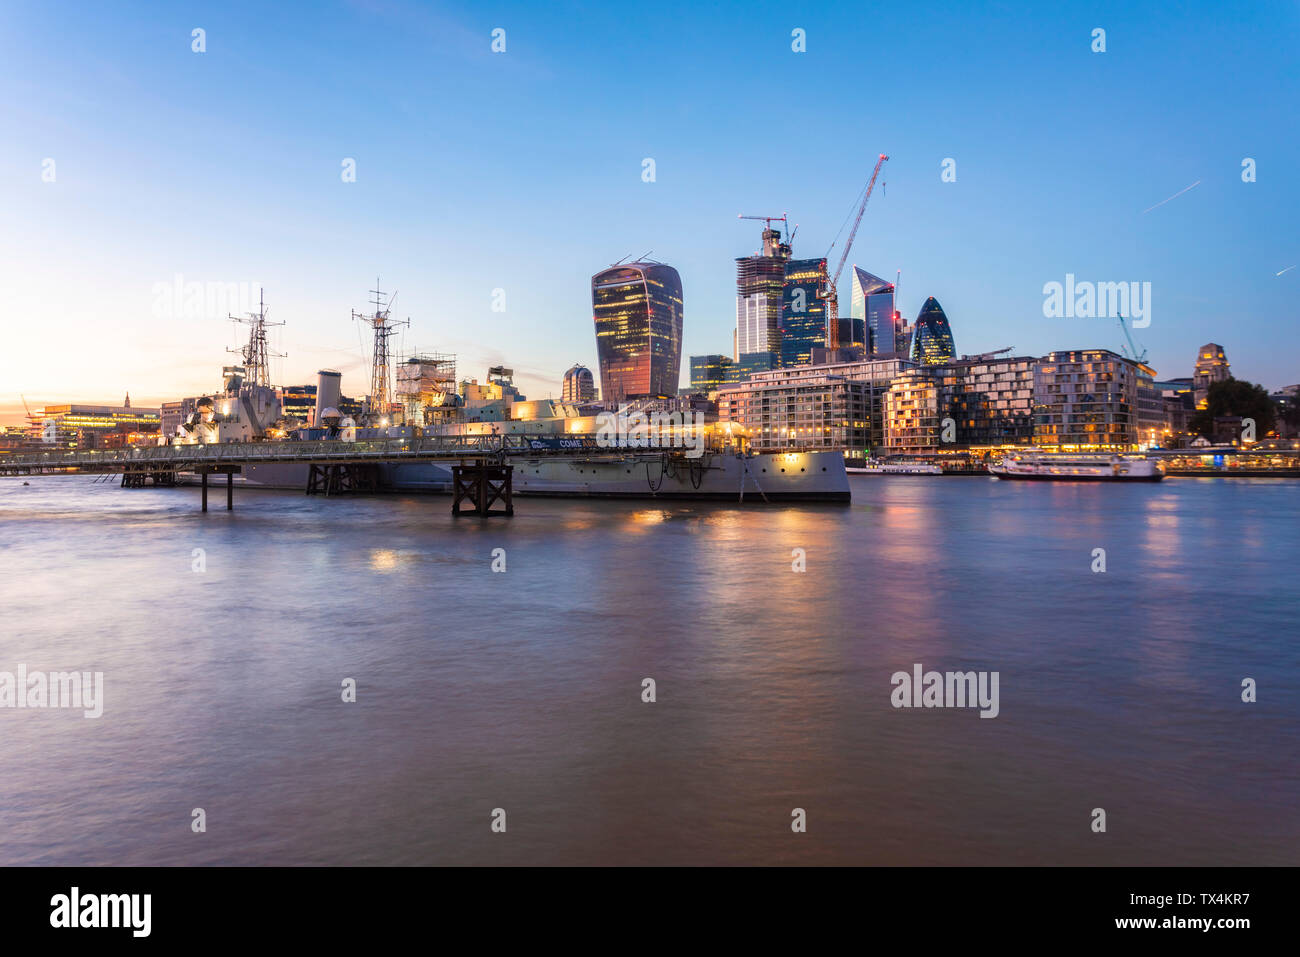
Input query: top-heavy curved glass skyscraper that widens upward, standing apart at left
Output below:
<box><xmin>592</xmin><ymin>260</ymin><xmax>683</xmax><ymax>402</ymax></box>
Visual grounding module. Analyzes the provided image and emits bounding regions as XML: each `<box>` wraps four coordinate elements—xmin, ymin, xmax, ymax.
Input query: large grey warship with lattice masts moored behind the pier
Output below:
<box><xmin>163</xmin><ymin>306</ymin><xmax>852</xmax><ymax>503</ymax></box>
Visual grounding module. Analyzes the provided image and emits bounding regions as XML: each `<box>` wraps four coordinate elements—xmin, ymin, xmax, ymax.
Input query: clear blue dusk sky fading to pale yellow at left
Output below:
<box><xmin>0</xmin><ymin>0</ymin><xmax>1300</xmax><ymax>423</ymax></box>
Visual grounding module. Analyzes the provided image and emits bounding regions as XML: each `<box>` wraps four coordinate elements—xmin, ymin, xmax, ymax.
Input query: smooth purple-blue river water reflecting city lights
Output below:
<box><xmin>0</xmin><ymin>476</ymin><xmax>1300</xmax><ymax>865</ymax></box>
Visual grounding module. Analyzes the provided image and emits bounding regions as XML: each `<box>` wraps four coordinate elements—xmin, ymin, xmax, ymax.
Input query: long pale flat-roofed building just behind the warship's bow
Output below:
<box><xmin>718</xmin><ymin>358</ymin><xmax>913</xmax><ymax>456</ymax></box>
